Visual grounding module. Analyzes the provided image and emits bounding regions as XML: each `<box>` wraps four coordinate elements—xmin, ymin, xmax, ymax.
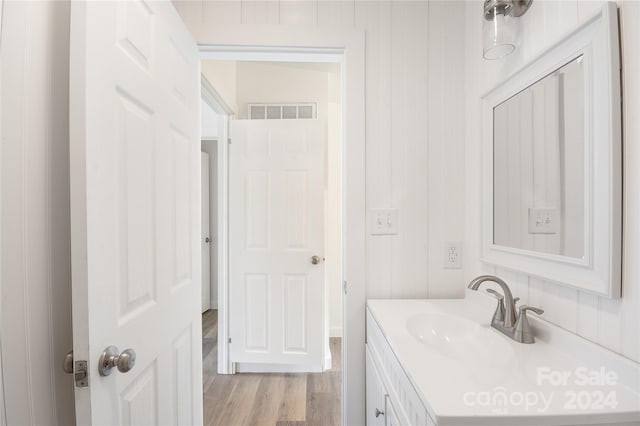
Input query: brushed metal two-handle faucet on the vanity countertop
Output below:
<box><xmin>467</xmin><ymin>275</ymin><xmax>544</xmax><ymax>343</ymax></box>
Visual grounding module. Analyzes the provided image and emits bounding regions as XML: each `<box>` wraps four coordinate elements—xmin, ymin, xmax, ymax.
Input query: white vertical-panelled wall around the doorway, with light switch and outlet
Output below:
<box><xmin>174</xmin><ymin>0</ymin><xmax>465</xmax><ymax>298</ymax></box>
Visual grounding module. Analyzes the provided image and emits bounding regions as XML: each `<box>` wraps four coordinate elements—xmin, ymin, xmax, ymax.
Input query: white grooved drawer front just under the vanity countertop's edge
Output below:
<box><xmin>367</xmin><ymin>309</ymin><xmax>435</xmax><ymax>426</ymax></box>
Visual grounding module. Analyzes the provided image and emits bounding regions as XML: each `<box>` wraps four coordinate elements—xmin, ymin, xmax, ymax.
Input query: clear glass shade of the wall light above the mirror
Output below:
<box><xmin>482</xmin><ymin>8</ymin><xmax>517</xmax><ymax>59</ymax></box>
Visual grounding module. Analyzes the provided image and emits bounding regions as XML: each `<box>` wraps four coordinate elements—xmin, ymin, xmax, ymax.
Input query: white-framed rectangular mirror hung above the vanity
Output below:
<box><xmin>482</xmin><ymin>3</ymin><xmax>622</xmax><ymax>298</ymax></box>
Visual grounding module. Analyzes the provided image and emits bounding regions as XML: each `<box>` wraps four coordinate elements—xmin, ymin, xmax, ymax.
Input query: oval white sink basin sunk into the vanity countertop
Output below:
<box><xmin>406</xmin><ymin>313</ymin><xmax>513</xmax><ymax>367</ymax></box>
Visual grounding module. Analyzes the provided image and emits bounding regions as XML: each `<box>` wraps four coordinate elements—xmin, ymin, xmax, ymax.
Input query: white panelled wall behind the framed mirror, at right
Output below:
<box><xmin>465</xmin><ymin>0</ymin><xmax>640</xmax><ymax>361</ymax></box>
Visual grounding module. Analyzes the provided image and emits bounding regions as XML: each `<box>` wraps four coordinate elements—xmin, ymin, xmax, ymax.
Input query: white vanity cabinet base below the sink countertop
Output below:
<box><xmin>366</xmin><ymin>310</ymin><xmax>435</xmax><ymax>426</ymax></box>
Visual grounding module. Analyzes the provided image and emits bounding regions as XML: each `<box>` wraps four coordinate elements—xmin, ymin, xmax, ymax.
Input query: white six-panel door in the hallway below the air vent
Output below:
<box><xmin>229</xmin><ymin>120</ymin><xmax>325</xmax><ymax>371</ymax></box>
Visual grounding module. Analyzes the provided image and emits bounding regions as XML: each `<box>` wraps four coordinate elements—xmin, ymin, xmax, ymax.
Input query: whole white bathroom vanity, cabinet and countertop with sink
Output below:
<box><xmin>366</xmin><ymin>292</ymin><xmax>640</xmax><ymax>426</ymax></box>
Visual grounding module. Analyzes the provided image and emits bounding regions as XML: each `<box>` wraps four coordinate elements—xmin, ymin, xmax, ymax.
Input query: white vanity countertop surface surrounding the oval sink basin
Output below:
<box><xmin>367</xmin><ymin>295</ymin><xmax>640</xmax><ymax>426</ymax></box>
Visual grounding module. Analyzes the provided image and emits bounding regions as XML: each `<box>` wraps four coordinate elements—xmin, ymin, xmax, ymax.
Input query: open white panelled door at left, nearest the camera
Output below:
<box><xmin>70</xmin><ymin>1</ymin><xmax>202</xmax><ymax>425</ymax></box>
